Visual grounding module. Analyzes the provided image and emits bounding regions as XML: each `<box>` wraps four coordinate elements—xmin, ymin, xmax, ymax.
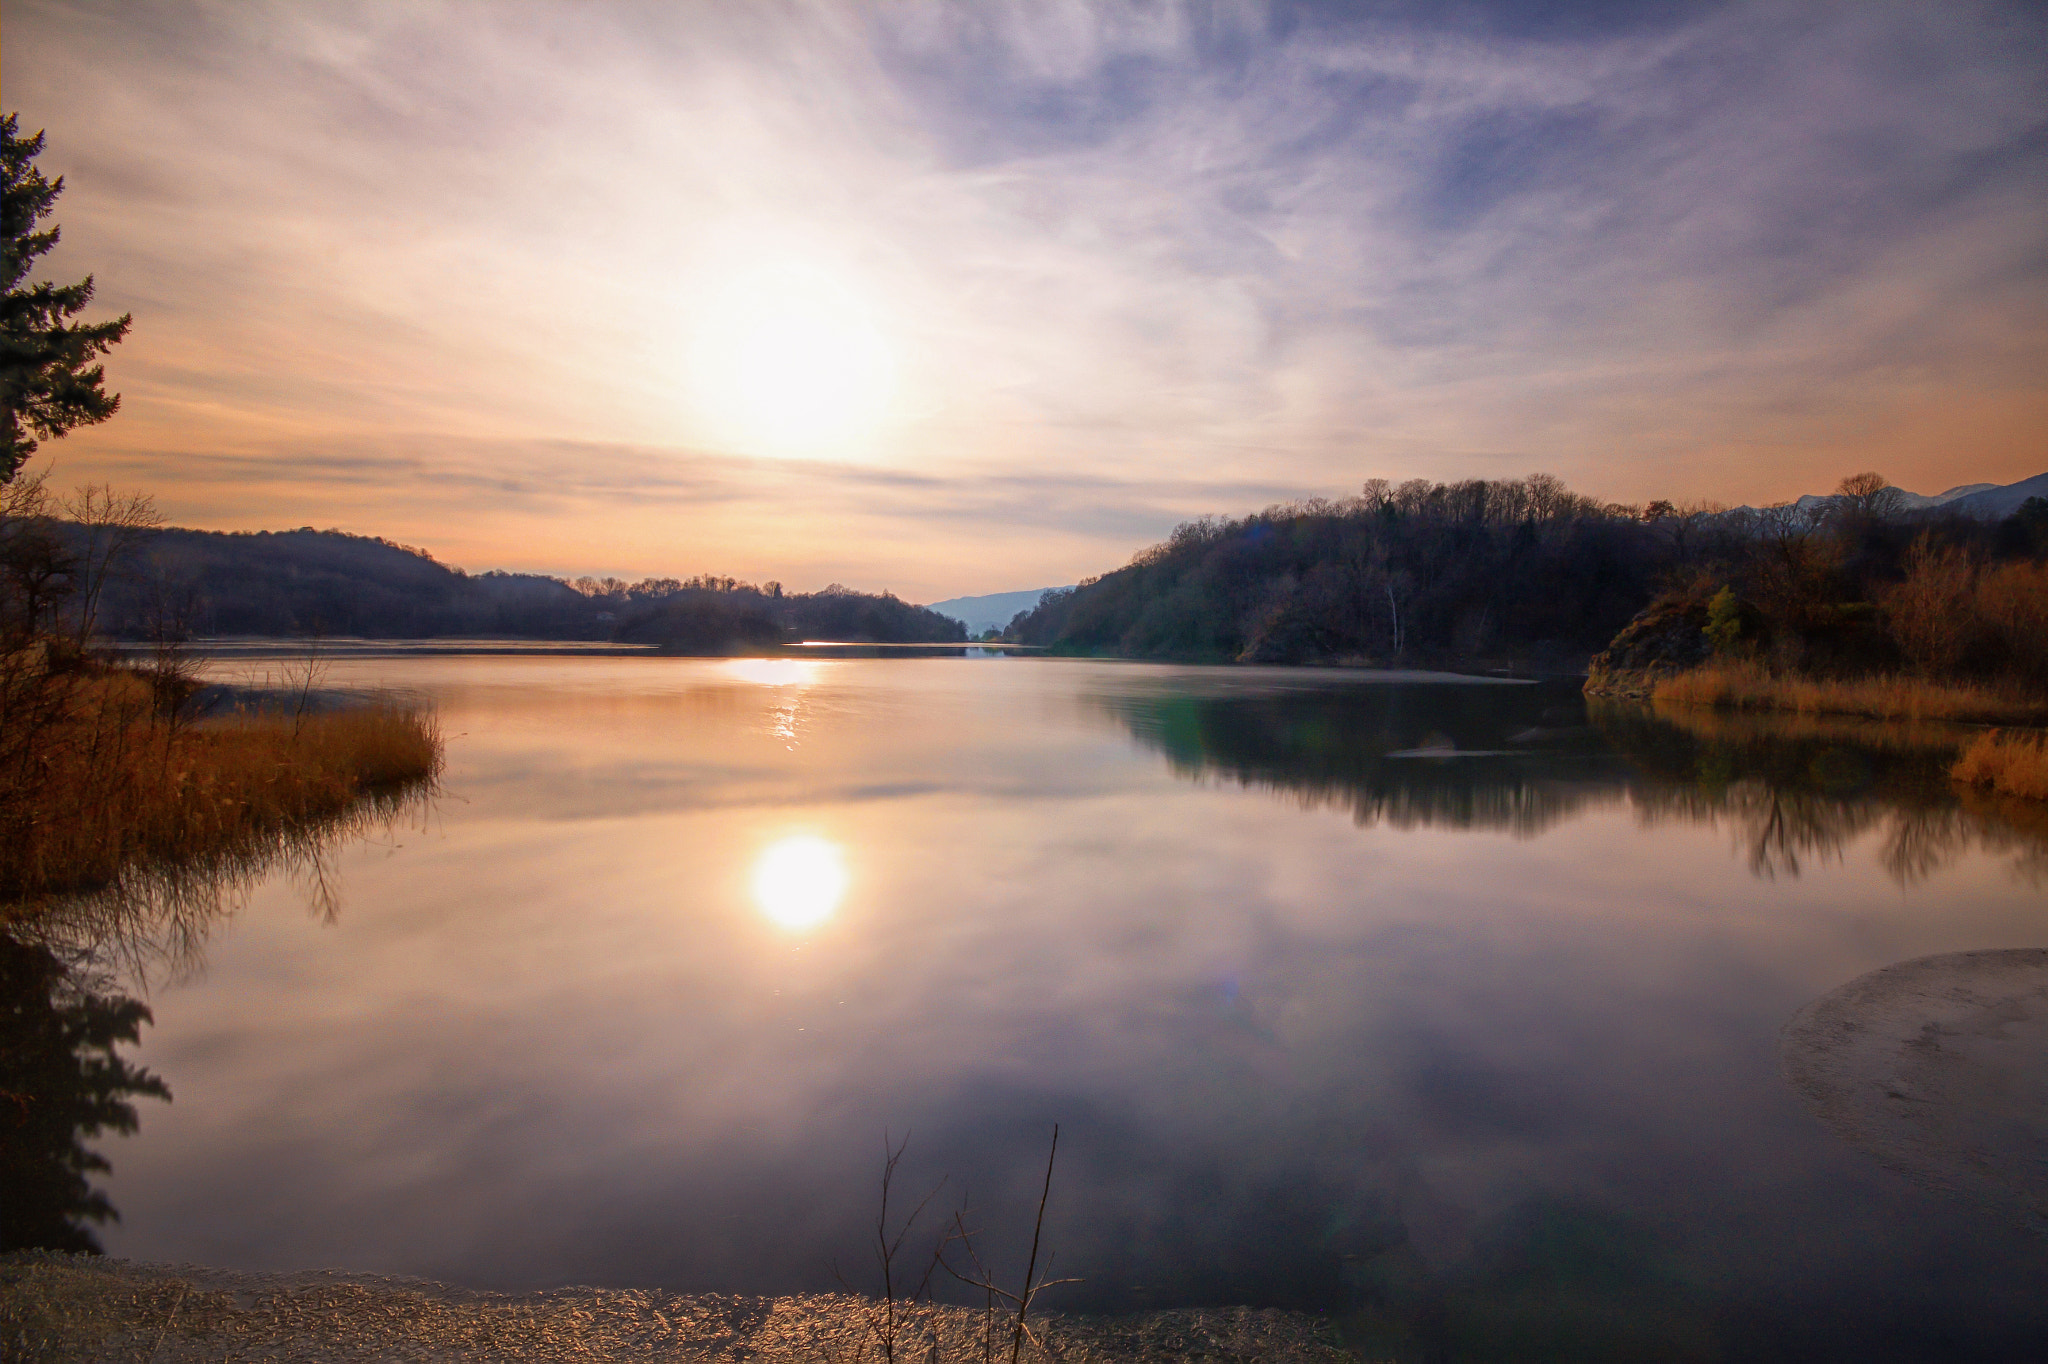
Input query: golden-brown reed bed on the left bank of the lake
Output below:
<box><xmin>0</xmin><ymin>672</ymin><xmax>440</xmax><ymax>918</ymax></box>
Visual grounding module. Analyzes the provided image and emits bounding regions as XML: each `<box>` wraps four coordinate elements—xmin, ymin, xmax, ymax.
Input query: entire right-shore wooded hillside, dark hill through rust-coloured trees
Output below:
<box><xmin>1008</xmin><ymin>473</ymin><xmax>2048</xmax><ymax>672</ymax></box>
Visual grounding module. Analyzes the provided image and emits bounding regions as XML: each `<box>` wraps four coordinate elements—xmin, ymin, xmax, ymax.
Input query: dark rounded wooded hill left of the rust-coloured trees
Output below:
<box><xmin>1008</xmin><ymin>473</ymin><xmax>1662</xmax><ymax>666</ymax></box>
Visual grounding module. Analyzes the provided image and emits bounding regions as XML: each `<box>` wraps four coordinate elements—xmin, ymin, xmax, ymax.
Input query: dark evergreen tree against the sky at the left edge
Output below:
<box><xmin>0</xmin><ymin>115</ymin><xmax>129</xmax><ymax>483</ymax></box>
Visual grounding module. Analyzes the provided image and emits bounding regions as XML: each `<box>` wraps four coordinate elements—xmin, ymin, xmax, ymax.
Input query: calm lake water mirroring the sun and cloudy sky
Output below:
<box><xmin>59</xmin><ymin>649</ymin><xmax>2048</xmax><ymax>1360</ymax></box>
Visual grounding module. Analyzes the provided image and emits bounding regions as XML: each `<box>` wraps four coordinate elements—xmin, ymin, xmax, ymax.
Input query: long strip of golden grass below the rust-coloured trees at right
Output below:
<box><xmin>1651</xmin><ymin>664</ymin><xmax>2048</xmax><ymax>725</ymax></box>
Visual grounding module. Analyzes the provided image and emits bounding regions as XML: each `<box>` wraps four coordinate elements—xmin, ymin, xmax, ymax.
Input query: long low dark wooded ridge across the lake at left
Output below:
<box><xmin>0</xmin><ymin>518</ymin><xmax>965</xmax><ymax>653</ymax></box>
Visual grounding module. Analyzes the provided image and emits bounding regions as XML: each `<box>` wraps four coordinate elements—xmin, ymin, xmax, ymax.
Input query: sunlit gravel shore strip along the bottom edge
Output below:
<box><xmin>0</xmin><ymin>1251</ymin><xmax>1352</xmax><ymax>1364</ymax></box>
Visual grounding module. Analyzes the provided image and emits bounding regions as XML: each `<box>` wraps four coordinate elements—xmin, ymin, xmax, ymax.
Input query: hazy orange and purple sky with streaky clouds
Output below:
<box><xmin>0</xmin><ymin>0</ymin><xmax>2048</xmax><ymax>600</ymax></box>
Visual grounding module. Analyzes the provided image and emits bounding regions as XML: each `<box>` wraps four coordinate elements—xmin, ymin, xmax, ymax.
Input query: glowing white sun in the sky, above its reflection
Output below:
<box><xmin>690</xmin><ymin>264</ymin><xmax>895</xmax><ymax>455</ymax></box>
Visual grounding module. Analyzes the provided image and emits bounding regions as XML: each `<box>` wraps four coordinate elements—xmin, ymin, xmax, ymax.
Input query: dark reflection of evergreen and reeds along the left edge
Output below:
<box><xmin>0</xmin><ymin>782</ymin><xmax>434</xmax><ymax>1253</ymax></box>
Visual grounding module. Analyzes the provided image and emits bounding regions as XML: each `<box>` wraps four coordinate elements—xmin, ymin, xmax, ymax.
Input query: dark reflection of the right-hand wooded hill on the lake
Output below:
<box><xmin>1098</xmin><ymin>682</ymin><xmax>2048</xmax><ymax>885</ymax></box>
